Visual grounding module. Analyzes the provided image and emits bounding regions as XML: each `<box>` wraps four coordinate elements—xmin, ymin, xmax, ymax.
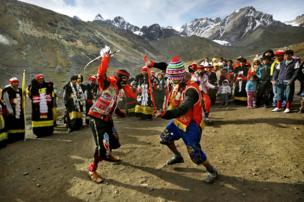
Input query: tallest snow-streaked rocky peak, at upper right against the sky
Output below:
<box><xmin>181</xmin><ymin>7</ymin><xmax>274</xmax><ymax>43</ymax></box>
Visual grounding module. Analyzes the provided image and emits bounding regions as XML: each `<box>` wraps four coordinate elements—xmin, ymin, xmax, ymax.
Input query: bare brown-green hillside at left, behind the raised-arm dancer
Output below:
<box><xmin>0</xmin><ymin>1</ymin><xmax>159</xmax><ymax>85</ymax></box>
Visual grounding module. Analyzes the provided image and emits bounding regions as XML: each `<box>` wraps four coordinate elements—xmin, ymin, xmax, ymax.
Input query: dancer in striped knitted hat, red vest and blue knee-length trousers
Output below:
<box><xmin>153</xmin><ymin>57</ymin><xmax>218</xmax><ymax>183</ymax></box>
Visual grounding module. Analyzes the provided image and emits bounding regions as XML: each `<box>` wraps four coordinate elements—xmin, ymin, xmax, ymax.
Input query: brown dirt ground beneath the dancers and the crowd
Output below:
<box><xmin>0</xmin><ymin>106</ymin><xmax>304</xmax><ymax>202</ymax></box>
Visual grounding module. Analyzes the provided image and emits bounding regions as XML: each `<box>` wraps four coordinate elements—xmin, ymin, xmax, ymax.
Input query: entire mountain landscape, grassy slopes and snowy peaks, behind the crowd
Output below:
<box><xmin>0</xmin><ymin>0</ymin><xmax>304</xmax><ymax>86</ymax></box>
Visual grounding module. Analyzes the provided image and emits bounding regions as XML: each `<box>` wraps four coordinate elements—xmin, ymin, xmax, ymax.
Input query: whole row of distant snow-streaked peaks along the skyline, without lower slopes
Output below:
<box><xmin>95</xmin><ymin>6</ymin><xmax>304</xmax><ymax>46</ymax></box>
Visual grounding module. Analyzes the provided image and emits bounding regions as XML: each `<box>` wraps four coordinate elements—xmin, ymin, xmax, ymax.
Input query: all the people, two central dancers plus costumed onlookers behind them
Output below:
<box><xmin>0</xmin><ymin>47</ymin><xmax>304</xmax><ymax>183</ymax></box>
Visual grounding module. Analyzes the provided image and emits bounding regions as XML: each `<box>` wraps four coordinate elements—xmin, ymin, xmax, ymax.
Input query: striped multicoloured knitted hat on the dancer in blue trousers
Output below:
<box><xmin>166</xmin><ymin>56</ymin><xmax>186</xmax><ymax>81</ymax></box>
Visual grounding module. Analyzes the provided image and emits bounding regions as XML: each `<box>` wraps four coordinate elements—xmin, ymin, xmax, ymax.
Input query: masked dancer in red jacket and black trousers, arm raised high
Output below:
<box><xmin>88</xmin><ymin>46</ymin><xmax>136</xmax><ymax>183</ymax></box>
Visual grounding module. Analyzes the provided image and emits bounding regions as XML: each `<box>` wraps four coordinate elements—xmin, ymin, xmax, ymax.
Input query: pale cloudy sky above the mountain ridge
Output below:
<box><xmin>22</xmin><ymin>0</ymin><xmax>304</xmax><ymax>28</ymax></box>
